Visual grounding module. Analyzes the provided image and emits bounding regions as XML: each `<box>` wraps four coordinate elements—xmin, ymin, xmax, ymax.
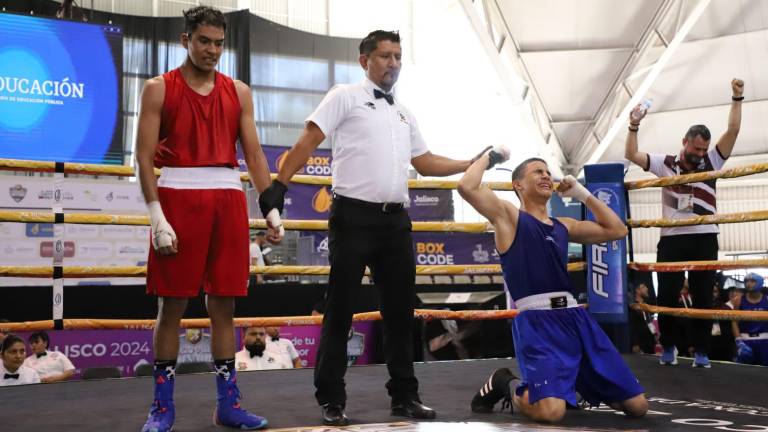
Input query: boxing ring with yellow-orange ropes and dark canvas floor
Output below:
<box><xmin>0</xmin><ymin>160</ymin><xmax>768</xmax><ymax>432</ymax></box>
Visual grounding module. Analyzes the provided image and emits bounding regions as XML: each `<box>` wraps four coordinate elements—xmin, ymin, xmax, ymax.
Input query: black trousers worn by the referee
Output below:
<box><xmin>315</xmin><ymin>197</ymin><xmax>418</xmax><ymax>406</ymax></box>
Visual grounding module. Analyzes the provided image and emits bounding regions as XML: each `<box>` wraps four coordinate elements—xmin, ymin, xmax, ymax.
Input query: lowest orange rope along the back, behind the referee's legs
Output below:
<box><xmin>0</xmin><ymin>309</ymin><xmax>519</xmax><ymax>332</ymax></box>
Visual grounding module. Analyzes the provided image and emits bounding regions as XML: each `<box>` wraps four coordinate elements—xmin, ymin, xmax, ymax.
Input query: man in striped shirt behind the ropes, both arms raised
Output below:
<box><xmin>625</xmin><ymin>79</ymin><xmax>744</xmax><ymax>368</ymax></box>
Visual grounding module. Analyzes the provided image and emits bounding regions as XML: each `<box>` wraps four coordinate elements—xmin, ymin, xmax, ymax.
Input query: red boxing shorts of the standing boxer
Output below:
<box><xmin>147</xmin><ymin>187</ymin><xmax>249</xmax><ymax>297</ymax></box>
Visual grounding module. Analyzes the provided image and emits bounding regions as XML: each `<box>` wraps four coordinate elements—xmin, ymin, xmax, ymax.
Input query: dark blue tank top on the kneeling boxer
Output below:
<box><xmin>500</xmin><ymin>210</ymin><xmax>573</xmax><ymax>300</ymax></box>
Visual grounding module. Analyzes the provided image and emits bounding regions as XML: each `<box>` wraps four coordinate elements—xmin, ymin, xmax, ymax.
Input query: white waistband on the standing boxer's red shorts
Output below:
<box><xmin>157</xmin><ymin>167</ymin><xmax>243</xmax><ymax>190</ymax></box>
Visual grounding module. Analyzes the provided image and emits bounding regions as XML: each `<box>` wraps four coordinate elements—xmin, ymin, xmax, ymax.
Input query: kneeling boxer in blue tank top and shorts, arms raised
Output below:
<box><xmin>459</xmin><ymin>148</ymin><xmax>648</xmax><ymax>422</ymax></box>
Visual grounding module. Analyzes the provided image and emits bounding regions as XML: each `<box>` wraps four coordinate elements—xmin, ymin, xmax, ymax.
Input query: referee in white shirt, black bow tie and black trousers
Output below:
<box><xmin>259</xmin><ymin>30</ymin><xmax>484</xmax><ymax>426</ymax></box>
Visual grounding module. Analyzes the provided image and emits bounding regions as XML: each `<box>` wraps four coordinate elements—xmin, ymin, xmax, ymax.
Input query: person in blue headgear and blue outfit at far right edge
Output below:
<box><xmin>732</xmin><ymin>273</ymin><xmax>768</xmax><ymax>366</ymax></box>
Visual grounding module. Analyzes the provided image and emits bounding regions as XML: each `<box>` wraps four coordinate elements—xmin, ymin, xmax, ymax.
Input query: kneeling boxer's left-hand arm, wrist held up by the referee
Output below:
<box><xmin>457</xmin><ymin>151</ymin><xmax>519</xmax><ymax>252</ymax></box>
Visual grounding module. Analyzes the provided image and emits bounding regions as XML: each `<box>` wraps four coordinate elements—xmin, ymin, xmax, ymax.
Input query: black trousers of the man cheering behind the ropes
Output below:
<box><xmin>656</xmin><ymin>234</ymin><xmax>719</xmax><ymax>354</ymax></box>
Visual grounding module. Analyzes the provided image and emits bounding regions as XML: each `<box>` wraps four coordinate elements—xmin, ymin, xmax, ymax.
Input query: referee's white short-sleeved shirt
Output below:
<box><xmin>306</xmin><ymin>78</ymin><xmax>428</xmax><ymax>203</ymax></box>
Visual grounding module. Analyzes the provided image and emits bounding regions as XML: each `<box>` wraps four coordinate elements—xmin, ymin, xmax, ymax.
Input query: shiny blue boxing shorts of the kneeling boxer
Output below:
<box><xmin>512</xmin><ymin>307</ymin><xmax>644</xmax><ymax>406</ymax></box>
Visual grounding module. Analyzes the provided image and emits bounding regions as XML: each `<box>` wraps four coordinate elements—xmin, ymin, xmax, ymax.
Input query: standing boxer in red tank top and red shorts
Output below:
<box><xmin>136</xmin><ymin>6</ymin><xmax>281</xmax><ymax>432</ymax></box>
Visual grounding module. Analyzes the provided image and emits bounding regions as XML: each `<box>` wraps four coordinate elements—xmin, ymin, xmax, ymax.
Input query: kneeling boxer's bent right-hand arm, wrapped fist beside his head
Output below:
<box><xmin>557</xmin><ymin>176</ymin><xmax>627</xmax><ymax>243</ymax></box>
